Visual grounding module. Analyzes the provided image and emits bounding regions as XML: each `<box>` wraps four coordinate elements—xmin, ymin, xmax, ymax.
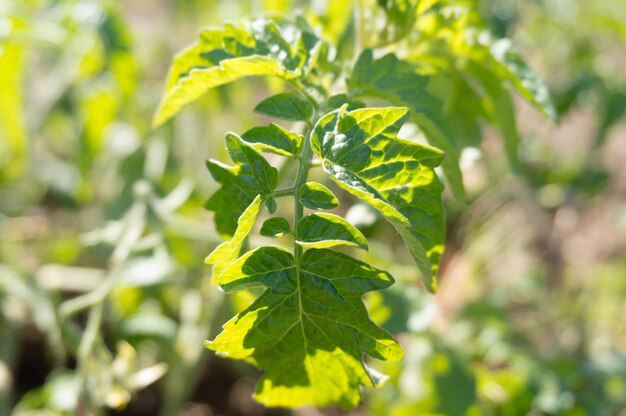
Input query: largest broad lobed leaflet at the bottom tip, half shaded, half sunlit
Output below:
<box><xmin>206</xmin><ymin>247</ymin><xmax>402</xmax><ymax>408</ymax></box>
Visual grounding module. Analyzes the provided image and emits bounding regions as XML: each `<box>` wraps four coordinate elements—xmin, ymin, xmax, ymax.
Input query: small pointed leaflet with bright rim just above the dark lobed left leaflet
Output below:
<box><xmin>241</xmin><ymin>123</ymin><xmax>302</xmax><ymax>157</ymax></box>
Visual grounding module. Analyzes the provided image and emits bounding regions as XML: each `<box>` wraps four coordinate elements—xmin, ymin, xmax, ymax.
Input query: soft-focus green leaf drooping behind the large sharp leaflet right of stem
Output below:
<box><xmin>348</xmin><ymin>49</ymin><xmax>466</xmax><ymax>205</ymax></box>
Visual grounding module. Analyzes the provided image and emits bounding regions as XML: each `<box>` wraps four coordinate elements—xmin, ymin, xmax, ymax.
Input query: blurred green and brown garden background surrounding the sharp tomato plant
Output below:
<box><xmin>0</xmin><ymin>0</ymin><xmax>626</xmax><ymax>416</ymax></box>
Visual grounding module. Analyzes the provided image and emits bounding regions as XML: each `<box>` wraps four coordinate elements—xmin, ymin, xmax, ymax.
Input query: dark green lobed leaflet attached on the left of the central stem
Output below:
<box><xmin>206</xmin><ymin>133</ymin><xmax>278</xmax><ymax>238</ymax></box>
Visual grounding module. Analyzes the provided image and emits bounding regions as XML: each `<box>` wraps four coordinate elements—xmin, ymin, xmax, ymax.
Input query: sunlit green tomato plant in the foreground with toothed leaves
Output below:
<box><xmin>154</xmin><ymin>1</ymin><xmax>556</xmax><ymax>408</ymax></box>
